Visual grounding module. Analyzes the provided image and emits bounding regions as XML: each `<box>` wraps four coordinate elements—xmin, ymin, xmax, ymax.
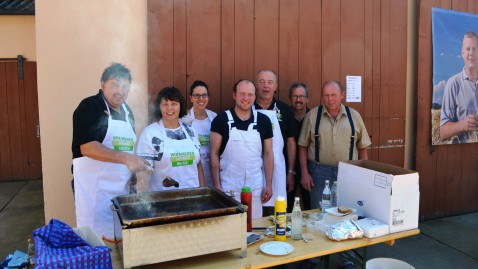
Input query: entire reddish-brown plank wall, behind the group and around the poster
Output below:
<box><xmin>148</xmin><ymin>0</ymin><xmax>478</xmax><ymax>219</ymax></box>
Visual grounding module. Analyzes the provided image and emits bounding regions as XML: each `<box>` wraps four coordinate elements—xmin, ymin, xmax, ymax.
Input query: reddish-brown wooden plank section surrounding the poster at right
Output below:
<box><xmin>416</xmin><ymin>0</ymin><xmax>478</xmax><ymax>218</ymax></box>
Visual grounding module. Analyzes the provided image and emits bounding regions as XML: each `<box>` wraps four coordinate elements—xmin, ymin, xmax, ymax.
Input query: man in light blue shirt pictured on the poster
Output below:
<box><xmin>440</xmin><ymin>32</ymin><xmax>478</xmax><ymax>144</ymax></box>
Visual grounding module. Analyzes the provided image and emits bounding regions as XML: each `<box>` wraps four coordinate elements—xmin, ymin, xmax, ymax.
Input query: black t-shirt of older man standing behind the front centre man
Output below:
<box><xmin>254</xmin><ymin>98</ymin><xmax>300</xmax><ymax>165</ymax></box>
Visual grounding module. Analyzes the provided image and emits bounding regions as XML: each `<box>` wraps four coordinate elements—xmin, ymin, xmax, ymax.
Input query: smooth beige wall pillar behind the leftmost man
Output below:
<box><xmin>35</xmin><ymin>0</ymin><xmax>147</xmax><ymax>226</ymax></box>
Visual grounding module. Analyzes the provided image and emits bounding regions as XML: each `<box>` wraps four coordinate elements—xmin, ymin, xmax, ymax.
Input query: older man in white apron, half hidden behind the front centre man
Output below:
<box><xmin>254</xmin><ymin>70</ymin><xmax>299</xmax><ymax>216</ymax></box>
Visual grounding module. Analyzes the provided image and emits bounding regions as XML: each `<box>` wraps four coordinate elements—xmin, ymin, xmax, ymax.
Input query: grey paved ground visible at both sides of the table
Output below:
<box><xmin>0</xmin><ymin>180</ymin><xmax>478</xmax><ymax>269</ymax></box>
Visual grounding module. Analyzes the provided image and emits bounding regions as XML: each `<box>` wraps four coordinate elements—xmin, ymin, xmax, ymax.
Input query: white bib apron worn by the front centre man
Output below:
<box><xmin>219</xmin><ymin>110</ymin><xmax>264</xmax><ymax>219</ymax></box>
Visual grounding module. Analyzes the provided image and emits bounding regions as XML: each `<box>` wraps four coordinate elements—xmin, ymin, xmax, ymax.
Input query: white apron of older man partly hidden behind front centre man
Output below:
<box><xmin>254</xmin><ymin>105</ymin><xmax>287</xmax><ymax>206</ymax></box>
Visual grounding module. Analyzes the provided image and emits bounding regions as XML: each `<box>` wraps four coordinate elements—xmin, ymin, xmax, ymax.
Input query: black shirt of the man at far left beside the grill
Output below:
<box><xmin>71</xmin><ymin>90</ymin><xmax>134</xmax><ymax>159</ymax></box>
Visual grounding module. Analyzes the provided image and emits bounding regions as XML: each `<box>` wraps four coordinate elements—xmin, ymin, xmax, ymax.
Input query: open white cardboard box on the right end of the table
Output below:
<box><xmin>337</xmin><ymin>160</ymin><xmax>420</xmax><ymax>233</ymax></box>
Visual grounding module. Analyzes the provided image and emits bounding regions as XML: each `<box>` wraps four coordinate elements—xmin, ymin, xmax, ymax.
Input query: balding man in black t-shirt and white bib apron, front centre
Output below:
<box><xmin>211</xmin><ymin>80</ymin><xmax>274</xmax><ymax>218</ymax></box>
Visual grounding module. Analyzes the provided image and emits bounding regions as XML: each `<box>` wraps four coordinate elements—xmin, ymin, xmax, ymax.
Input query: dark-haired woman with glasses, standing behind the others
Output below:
<box><xmin>181</xmin><ymin>80</ymin><xmax>217</xmax><ymax>187</ymax></box>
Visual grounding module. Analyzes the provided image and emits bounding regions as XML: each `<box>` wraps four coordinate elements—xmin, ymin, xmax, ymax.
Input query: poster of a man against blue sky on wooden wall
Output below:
<box><xmin>431</xmin><ymin>8</ymin><xmax>478</xmax><ymax>145</ymax></box>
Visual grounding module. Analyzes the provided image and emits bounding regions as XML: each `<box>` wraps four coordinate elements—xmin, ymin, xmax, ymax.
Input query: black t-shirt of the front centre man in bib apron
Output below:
<box><xmin>211</xmin><ymin>109</ymin><xmax>273</xmax><ymax>156</ymax></box>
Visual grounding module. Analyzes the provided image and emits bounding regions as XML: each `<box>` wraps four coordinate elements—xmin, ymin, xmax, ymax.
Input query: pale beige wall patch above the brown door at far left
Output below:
<box><xmin>0</xmin><ymin>15</ymin><xmax>36</xmax><ymax>61</ymax></box>
